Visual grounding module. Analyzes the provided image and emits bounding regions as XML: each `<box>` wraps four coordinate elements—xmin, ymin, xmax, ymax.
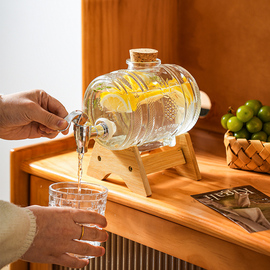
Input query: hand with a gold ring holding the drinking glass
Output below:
<box><xmin>22</xmin><ymin>205</ymin><xmax>108</xmax><ymax>268</ymax></box>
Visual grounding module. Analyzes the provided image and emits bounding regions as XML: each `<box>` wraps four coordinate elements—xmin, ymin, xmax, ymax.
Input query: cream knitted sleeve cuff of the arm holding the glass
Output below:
<box><xmin>0</xmin><ymin>200</ymin><xmax>36</xmax><ymax>269</ymax></box>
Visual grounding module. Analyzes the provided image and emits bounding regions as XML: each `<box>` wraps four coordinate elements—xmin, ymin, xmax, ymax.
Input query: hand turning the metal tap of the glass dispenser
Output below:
<box><xmin>0</xmin><ymin>90</ymin><xmax>68</xmax><ymax>140</ymax></box>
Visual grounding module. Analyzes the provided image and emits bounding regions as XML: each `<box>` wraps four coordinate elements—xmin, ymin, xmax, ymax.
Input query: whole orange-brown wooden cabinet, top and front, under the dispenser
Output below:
<box><xmin>11</xmin><ymin>129</ymin><xmax>270</xmax><ymax>270</ymax></box>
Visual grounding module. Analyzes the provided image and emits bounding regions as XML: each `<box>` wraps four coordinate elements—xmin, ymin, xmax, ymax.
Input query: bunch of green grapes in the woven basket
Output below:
<box><xmin>221</xmin><ymin>99</ymin><xmax>270</xmax><ymax>142</ymax></box>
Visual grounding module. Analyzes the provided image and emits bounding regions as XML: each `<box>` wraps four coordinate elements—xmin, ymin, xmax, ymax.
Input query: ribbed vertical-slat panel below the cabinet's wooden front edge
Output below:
<box><xmin>52</xmin><ymin>232</ymin><xmax>204</xmax><ymax>270</ymax></box>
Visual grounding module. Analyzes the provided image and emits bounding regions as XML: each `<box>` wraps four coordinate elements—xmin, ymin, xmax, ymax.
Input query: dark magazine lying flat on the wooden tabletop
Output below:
<box><xmin>191</xmin><ymin>186</ymin><xmax>270</xmax><ymax>233</ymax></box>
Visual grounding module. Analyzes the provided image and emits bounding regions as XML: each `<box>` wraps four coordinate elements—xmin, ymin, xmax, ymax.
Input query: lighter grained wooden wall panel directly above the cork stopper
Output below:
<box><xmin>82</xmin><ymin>0</ymin><xmax>180</xmax><ymax>91</ymax></box>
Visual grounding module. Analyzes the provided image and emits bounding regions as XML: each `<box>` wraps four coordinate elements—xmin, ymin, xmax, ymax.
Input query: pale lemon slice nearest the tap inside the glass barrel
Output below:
<box><xmin>100</xmin><ymin>92</ymin><xmax>132</xmax><ymax>112</ymax></box>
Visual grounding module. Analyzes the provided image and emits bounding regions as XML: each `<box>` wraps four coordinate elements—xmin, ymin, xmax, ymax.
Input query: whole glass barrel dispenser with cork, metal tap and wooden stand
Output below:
<box><xmin>66</xmin><ymin>49</ymin><xmax>201</xmax><ymax>196</ymax></box>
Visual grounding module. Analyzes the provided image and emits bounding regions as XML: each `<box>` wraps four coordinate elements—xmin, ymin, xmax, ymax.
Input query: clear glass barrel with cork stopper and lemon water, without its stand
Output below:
<box><xmin>83</xmin><ymin>49</ymin><xmax>201</xmax><ymax>151</ymax></box>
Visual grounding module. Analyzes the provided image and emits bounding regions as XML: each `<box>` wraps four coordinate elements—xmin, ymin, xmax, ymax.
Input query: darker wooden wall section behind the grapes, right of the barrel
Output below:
<box><xmin>179</xmin><ymin>0</ymin><xmax>270</xmax><ymax>132</ymax></box>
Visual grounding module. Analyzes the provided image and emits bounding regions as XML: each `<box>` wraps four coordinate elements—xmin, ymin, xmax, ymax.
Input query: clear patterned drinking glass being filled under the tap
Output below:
<box><xmin>49</xmin><ymin>182</ymin><xmax>108</xmax><ymax>259</ymax></box>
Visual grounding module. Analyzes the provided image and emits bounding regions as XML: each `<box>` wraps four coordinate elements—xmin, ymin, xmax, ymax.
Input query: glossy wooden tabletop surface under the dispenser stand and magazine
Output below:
<box><xmin>17</xmin><ymin>130</ymin><xmax>270</xmax><ymax>256</ymax></box>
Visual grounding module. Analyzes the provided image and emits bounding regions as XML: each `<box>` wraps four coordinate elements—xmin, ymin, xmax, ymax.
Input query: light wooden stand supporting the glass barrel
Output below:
<box><xmin>87</xmin><ymin>133</ymin><xmax>201</xmax><ymax>196</ymax></box>
